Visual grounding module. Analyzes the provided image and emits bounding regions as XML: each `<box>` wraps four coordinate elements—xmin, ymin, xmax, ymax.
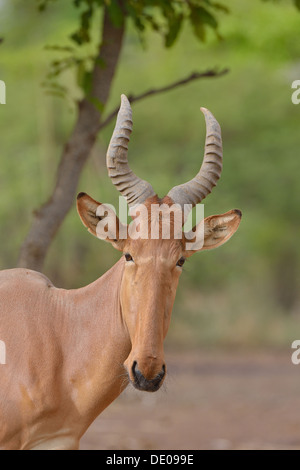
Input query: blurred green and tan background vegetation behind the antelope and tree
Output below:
<box><xmin>0</xmin><ymin>0</ymin><xmax>300</xmax><ymax>347</ymax></box>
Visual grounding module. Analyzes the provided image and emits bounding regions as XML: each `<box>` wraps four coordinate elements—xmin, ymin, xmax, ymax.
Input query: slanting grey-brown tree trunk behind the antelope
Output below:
<box><xmin>18</xmin><ymin>9</ymin><xmax>125</xmax><ymax>271</ymax></box>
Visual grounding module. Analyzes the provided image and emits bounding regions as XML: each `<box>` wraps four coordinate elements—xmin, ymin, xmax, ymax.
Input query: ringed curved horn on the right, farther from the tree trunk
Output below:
<box><xmin>168</xmin><ymin>108</ymin><xmax>223</xmax><ymax>208</ymax></box>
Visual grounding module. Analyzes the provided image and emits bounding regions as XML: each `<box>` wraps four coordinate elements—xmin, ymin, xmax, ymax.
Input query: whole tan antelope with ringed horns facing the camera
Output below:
<box><xmin>0</xmin><ymin>95</ymin><xmax>241</xmax><ymax>449</ymax></box>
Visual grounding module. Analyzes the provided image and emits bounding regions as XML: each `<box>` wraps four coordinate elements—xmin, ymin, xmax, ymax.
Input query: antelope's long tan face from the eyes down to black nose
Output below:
<box><xmin>121</xmin><ymin>204</ymin><xmax>186</xmax><ymax>392</ymax></box>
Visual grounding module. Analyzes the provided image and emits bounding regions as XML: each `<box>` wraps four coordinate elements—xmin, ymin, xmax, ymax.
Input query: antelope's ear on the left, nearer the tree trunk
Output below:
<box><xmin>77</xmin><ymin>193</ymin><xmax>127</xmax><ymax>251</ymax></box>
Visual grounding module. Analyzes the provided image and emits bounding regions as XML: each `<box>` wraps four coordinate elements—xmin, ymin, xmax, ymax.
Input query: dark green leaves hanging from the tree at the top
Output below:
<box><xmin>38</xmin><ymin>0</ymin><xmax>229</xmax><ymax>103</ymax></box>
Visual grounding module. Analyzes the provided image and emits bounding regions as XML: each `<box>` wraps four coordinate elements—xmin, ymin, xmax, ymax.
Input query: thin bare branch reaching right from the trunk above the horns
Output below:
<box><xmin>98</xmin><ymin>68</ymin><xmax>229</xmax><ymax>130</ymax></box>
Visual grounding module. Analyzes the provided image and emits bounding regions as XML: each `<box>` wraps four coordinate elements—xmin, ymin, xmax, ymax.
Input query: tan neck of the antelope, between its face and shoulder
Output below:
<box><xmin>61</xmin><ymin>258</ymin><xmax>131</xmax><ymax>436</ymax></box>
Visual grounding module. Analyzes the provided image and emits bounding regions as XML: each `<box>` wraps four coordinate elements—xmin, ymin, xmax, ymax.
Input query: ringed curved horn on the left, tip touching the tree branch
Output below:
<box><xmin>106</xmin><ymin>95</ymin><xmax>155</xmax><ymax>207</ymax></box>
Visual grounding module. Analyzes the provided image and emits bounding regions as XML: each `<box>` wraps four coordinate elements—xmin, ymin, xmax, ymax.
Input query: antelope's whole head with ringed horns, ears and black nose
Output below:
<box><xmin>77</xmin><ymin>95</ymin><xmax>241</xmax><ymax>391</ymax></box>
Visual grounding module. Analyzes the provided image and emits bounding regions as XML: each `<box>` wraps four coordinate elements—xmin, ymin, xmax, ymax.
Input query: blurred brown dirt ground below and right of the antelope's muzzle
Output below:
<box><xmin>80</xmin><ymin>350</ymin><xmax>300</xmax><ymax>450</ymax></box>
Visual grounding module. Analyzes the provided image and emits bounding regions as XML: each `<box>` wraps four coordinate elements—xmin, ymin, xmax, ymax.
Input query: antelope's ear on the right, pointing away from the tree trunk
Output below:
<box><xmin>185</xmin><ymin>209</ymin><xmax>242</xmax><ymax>256</ymax></box>
